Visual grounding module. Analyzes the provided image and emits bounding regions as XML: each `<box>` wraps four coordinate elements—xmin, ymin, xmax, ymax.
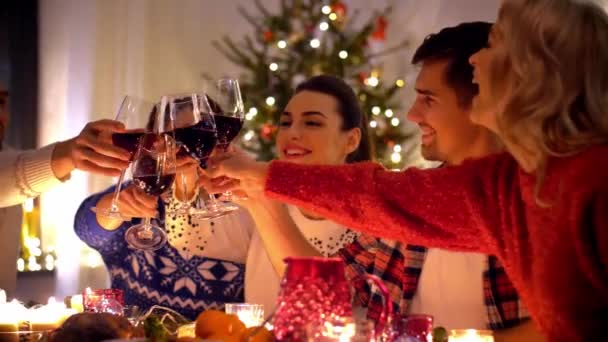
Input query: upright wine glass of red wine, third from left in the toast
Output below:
<box><xmin>163</xmin><ymin>93</ymin><xmax>217</xmax><ymax>218</ymax></box>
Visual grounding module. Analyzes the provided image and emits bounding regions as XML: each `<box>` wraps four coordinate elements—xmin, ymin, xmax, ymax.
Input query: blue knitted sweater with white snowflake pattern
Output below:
<box><xmin>74</xmin><ymin>187</ymin><xmax>245</xmax><ymax>320</ymax></box>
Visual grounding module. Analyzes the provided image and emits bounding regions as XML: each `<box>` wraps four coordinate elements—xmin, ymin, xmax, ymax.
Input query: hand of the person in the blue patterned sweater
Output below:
<box><xmin>97</xmin><ymin>184</ymin><xmax>158</xmax><ymax>230</ymax></box>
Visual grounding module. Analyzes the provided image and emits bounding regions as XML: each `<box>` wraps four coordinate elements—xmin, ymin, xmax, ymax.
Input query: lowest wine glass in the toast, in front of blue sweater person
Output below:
<box><xmin>125</xmin><ymin>133</ymin><xmax>176</xmax><ymax>251</ymax></box>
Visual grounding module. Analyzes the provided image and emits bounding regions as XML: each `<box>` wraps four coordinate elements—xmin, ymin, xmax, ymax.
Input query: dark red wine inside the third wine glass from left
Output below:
<box><xmin>173</xmin><ymin>121</ymin><xmax>218</xmax><ymax>167</ymax></box>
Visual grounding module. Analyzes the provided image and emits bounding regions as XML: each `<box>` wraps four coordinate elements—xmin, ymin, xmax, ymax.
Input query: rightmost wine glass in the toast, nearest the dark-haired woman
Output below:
<box><xmin>206</xmin><ymin>78</ymin><xmax>245</xmax><ymax>213</ymax></box>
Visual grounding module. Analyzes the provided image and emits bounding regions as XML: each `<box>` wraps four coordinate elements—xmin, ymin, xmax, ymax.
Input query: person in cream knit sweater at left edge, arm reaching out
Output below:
<box><xmin>0</xmin><ymin>84</ymin><xmax>129</xmax><ymax>295</ymax></box>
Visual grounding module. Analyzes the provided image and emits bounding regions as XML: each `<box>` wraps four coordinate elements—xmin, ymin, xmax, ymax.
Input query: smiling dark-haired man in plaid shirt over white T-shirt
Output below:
<box><xmin>404</xmin><ymin>22</ymin><xmax>542</xmax><ymax>341</ymax></box>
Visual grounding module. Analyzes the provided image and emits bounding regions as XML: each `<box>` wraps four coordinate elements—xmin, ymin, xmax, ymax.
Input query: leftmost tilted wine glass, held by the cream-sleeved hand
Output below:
<box><xmin>91</xmin><ymin>95</ymin><xmax>155</xmax><ymax>219</ymax></box>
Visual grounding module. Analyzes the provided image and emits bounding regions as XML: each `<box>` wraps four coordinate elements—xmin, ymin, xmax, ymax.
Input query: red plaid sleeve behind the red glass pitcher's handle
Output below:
<box><xmin>337</xmin><ymin>234</ymin><xmax>406</xmax><ymax>321</ymax></box>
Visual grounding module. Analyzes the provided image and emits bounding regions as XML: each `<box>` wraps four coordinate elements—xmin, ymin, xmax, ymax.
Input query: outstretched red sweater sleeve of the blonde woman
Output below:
<box><xmin>266</xmin><ymin>155</ymin><xmax>518</xmax><ymax>253</ymax></box>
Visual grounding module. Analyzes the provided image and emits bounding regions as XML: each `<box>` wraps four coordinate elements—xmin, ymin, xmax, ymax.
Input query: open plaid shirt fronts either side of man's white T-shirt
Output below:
<box><xmin>400</xmin><ymin>245</ymin><xmax>530</xmax><ymax>330</ymax></box>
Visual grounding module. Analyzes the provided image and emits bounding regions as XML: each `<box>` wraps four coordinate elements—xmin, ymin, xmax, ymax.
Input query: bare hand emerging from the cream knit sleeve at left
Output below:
<box><xmin>51</xmin><ymin>120</ymin><xmax>130</xmax><ymax>179</ymax></box>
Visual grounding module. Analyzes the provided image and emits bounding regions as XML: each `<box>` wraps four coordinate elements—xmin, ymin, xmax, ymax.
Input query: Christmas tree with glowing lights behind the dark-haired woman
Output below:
<box><xmin>214</xmin><ymin>0</ymin><xmax>412</xmax><ymax>168</ymax></box>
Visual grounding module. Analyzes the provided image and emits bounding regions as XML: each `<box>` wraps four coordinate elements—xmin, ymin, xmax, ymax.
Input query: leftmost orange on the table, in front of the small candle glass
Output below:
<box><xmin>195</xmin><ymin>310</ymin><xmax>245</xmax><ymax>338</ymax></box>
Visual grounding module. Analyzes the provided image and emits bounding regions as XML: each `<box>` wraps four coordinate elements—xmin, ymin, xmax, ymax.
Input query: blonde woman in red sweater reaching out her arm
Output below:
<box><xmin>203</xmin><ymin>0</ymin><xmax>608</xmax><ymax>341</ymax></box>
